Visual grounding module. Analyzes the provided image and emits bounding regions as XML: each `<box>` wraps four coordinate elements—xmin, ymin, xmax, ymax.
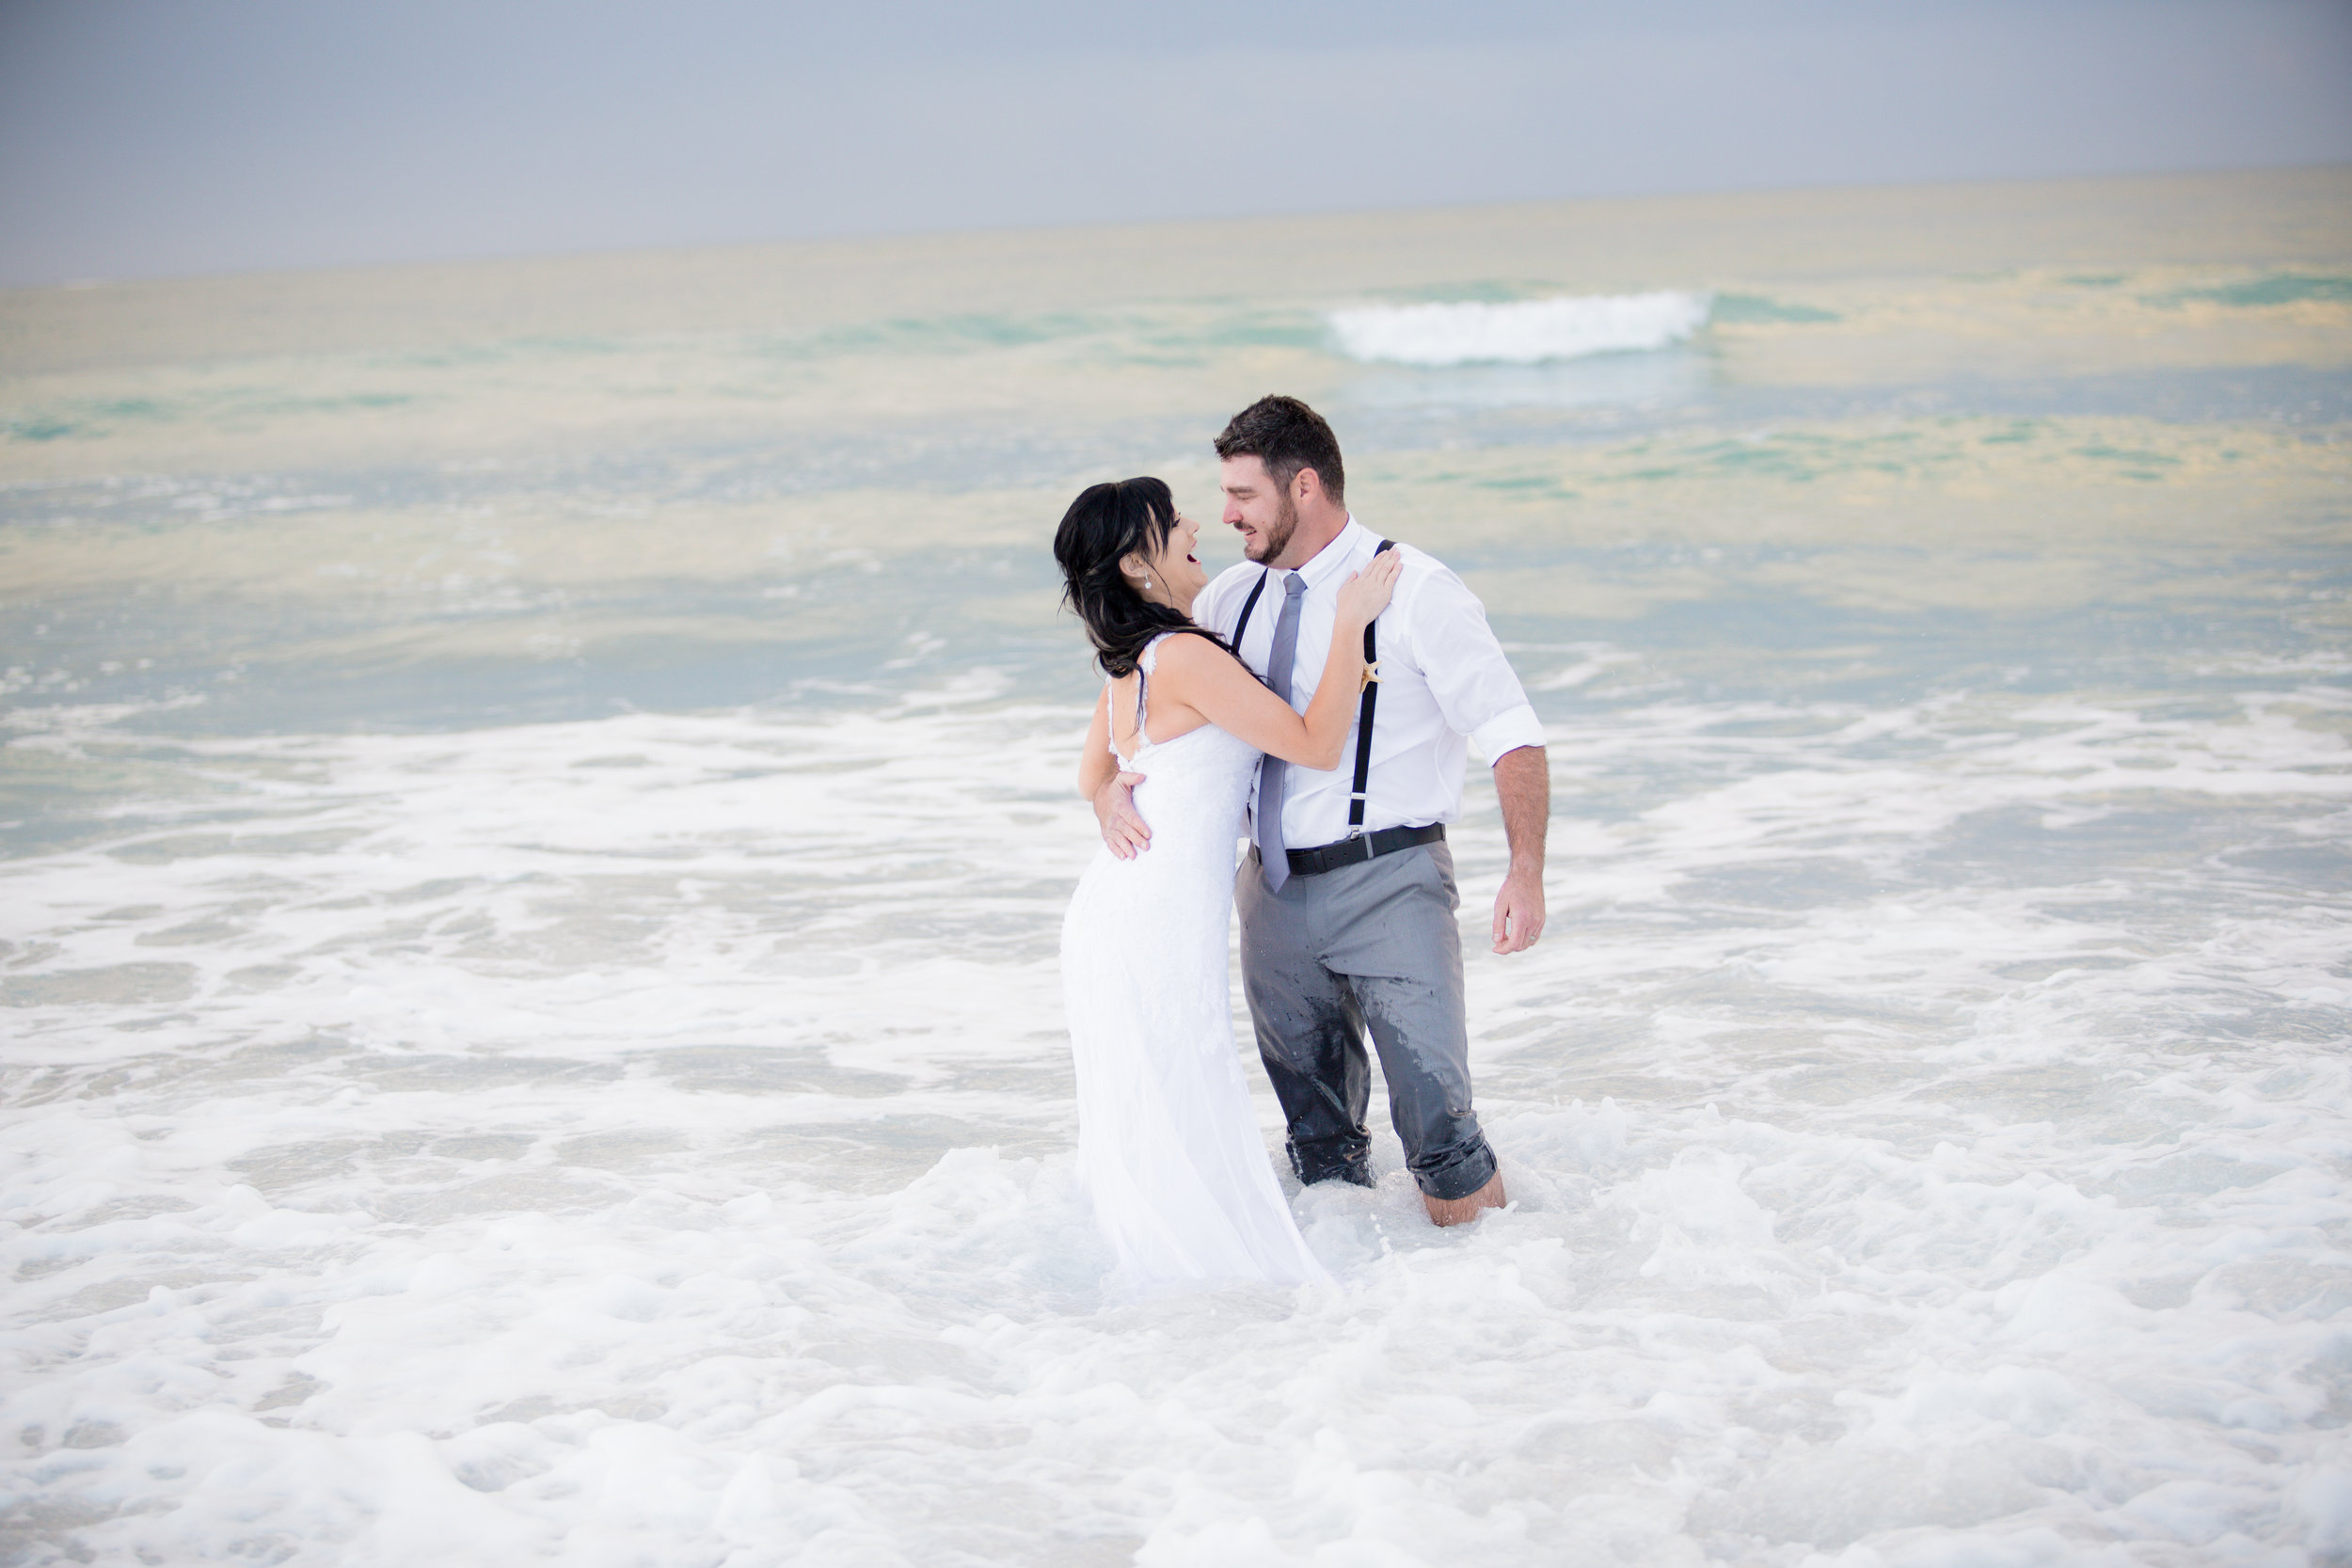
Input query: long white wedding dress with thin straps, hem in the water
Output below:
<box><xmin>1061</xmin><ymin>635</ymin><xmax>1329</xmax><ymax>1291</ymax></box>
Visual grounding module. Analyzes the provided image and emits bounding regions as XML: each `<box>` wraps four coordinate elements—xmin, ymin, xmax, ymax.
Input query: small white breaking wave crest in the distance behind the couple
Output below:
<box><xmin>1331</xmin><ymin>289</ymin><xmax>1712</xmax><ymax>367</ymax></box>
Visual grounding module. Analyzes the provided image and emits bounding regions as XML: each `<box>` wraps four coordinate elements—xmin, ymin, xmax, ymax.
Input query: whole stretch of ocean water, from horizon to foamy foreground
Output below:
<box><xmin>13</xmin><ymin>171</ymin><xmax>2352</xmax><ymax>1568</ymax></box>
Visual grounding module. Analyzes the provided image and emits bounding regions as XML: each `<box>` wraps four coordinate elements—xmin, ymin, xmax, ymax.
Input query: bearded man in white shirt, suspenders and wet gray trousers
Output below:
<box><xmin>1094</xmin><ymin>397</ymin><xmax>1552</xmax><ymax>1225</ymax></box>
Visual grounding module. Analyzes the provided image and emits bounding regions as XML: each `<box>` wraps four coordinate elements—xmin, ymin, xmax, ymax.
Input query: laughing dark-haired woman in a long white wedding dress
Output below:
<box><xmin>1054</xmin><ymin>480</ymin><xmax>1400</xmax><ymax>1289</ymax></box>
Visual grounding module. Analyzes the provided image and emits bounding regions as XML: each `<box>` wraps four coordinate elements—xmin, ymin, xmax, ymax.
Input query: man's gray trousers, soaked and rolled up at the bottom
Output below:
<box><xmin>1232</xmin><ymin>842</ymin><xmax>1494</xmax><ymax>1199</ymax></box>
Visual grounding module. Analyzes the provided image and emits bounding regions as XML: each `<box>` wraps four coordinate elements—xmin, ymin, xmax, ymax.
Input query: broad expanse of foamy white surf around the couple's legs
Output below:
<box><xmin>0</xmin><ymin>676</ymin><xmax>2352</xmax><ymax>1568</ymax></box>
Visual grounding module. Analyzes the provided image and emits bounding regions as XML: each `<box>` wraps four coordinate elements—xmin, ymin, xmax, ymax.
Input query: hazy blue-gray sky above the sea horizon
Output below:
<box><xmin>0</xmin><ymin>0</ymin><xmax>2352</xmax><ymax>284</ymax></box>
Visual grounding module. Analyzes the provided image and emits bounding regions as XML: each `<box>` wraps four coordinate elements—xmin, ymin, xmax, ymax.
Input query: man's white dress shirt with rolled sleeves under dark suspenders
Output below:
<box><xmin>1193</xmin><ymin>513</ymin><xmax>1543</xmax><ymax>848</ymax></box>
